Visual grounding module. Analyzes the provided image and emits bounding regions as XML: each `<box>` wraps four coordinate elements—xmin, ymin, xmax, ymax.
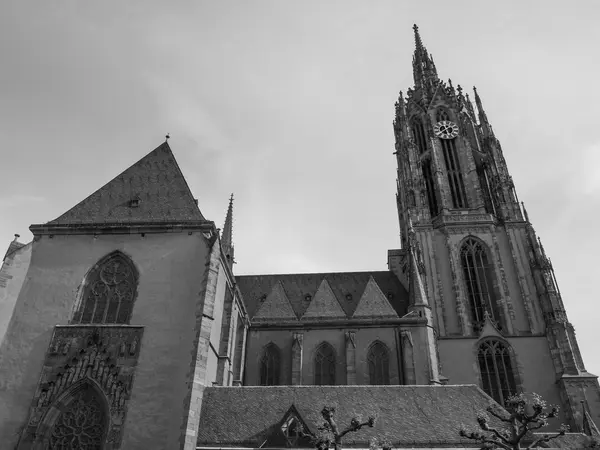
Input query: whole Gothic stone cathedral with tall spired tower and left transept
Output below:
<box><xmin>0</xmin><ymin>26</ymin><xmax>600</xmax><ymax>450</ymax></box>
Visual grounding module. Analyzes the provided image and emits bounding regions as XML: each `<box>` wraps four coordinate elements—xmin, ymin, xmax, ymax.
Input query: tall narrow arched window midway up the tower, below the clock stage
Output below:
<box><xmin>460</xmin><ymin>238</ymin><xmax>500</xmax><ymax>327</ymax></box>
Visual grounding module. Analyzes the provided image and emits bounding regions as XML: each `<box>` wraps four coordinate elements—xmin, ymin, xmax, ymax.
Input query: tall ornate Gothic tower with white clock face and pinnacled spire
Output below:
<box><xmin>389</xmin><ymin>25</ymin><xmax>600</xmax><ymax>430</ymax></box>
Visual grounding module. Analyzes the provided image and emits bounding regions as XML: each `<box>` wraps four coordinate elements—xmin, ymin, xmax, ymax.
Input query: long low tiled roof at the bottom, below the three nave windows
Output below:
<box><xmin>198</xmin><ymin>385</ymin><xmax>498</xmax><ymax>448</ymax></box>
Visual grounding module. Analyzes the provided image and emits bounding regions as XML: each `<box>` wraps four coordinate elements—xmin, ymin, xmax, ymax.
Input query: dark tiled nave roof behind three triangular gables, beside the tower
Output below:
<box><xmin>235</xmin><ymin>271</ymin><xmax>408</xmax><ymax>318</ymax></box>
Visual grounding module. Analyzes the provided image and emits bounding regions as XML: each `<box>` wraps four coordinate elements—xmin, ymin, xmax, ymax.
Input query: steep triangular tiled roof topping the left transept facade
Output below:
<box><xmin>49</xmin><ymin>142</ymin><xmax>204</xmax><ymax>225</ymax></box>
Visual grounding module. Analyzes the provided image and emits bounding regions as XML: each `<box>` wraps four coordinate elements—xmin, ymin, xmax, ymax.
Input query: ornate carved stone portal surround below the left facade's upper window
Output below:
<box><xmin>18</xmin><ymin>325</ymin><xmax>144</xmax><ymax>449</ymax></box>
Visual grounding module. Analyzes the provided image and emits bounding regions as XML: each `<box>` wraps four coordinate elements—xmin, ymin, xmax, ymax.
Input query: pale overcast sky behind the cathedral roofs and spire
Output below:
<box><xmin>0</xmin><ymin>0</ymin><xmax>600</xmax><ymax>374</ymax></box>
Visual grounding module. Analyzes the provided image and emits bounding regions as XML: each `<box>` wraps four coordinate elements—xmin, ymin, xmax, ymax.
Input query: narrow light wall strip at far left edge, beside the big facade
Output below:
<box><xmin>0</xmin><ymin>243</ymin><xmax>32</xmax><ymax>345</ymax></box>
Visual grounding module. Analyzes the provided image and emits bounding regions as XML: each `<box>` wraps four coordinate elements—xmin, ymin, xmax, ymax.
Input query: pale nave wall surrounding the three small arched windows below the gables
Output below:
<box><xmin>244</xmin><ymin>327</ymin><xmax>401</xmax><ymax>386</ymax></box>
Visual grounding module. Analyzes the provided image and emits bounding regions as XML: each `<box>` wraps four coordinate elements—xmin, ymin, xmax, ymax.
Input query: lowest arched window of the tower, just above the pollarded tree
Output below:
<box><xmin>477</xmin><ymin>340</ymin><xmax>517</xmax><ymax>405</ymax></box>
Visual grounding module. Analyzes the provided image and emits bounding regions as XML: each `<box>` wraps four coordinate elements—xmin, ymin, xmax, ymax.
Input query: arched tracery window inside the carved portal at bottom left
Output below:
<box><xmin>48</xmin><ymin>387</ymin><xmax>107</xmax><ymax>450</ymax></box>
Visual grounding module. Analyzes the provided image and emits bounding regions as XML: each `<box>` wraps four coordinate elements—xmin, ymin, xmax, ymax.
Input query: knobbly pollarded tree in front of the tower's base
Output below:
<box><xmin>459</xmin><ymin>393</ymin><xmax>569</xmax><ymax>450</ymax></box>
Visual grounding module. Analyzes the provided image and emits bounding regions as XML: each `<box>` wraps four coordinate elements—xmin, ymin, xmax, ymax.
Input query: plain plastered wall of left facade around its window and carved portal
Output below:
<box><xmin>0</xmin><ymin>232</ymin><xmax>213</xmax><ymax>449</ymax></box>
